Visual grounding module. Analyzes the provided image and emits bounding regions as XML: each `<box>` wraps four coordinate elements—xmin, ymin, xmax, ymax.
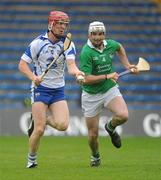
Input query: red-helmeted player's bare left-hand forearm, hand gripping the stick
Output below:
<box><xmin>18</xmin><ymin>59</ymin><xmax>41</xmax><ymax>85</ymax></box>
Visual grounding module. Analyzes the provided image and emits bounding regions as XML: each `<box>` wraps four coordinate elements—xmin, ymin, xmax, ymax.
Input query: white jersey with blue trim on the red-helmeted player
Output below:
<box><xmin>21</xmin><ymin>33</ymin><xmax>76</xmax><ymax>88</ymax></box>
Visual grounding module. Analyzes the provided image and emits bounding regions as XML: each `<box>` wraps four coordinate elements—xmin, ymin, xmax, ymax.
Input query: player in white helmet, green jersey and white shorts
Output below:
<box><xmin>80</xmin><ymin>21</ymin><xmax>137</xmax><ymax>166</ymax></box>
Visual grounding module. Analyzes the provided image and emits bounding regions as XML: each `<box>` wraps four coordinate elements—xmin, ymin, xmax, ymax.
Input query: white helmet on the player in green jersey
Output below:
<box><xmin>88</xmin><ymin>21</ymin><xmax>106</xmax><ymax>34</ymax></box>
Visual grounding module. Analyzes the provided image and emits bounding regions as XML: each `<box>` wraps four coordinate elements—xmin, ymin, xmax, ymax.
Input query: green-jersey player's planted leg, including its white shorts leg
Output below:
<box><xmin>82</xmin><ymin>91</ymin><xmax>104</xmax><ymax>166</ymax></box>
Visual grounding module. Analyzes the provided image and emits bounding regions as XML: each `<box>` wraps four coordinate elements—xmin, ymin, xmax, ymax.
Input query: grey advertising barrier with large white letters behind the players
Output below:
<box><xmin>0</xmin><ymin>109</ymin><xmax>161</xmax><ymax>137</ymax></box>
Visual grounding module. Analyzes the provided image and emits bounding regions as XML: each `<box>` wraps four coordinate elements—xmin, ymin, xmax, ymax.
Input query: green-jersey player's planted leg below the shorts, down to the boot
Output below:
<box><xmin>86</xmin><ymin>115</ymin><xmax>101</xmax><ymax>166</ymax></box>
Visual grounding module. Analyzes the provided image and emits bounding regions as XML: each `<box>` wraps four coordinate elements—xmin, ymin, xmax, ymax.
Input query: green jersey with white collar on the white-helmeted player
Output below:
<box><xmin>80</xmin><ymin>39</ymin><xmax>120</xmax><ymax>94</ymax></box>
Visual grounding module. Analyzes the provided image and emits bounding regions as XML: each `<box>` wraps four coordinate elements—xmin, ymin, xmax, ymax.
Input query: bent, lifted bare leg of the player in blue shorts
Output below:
<box><xmin>47</xmin><ymin>100</ymin><xmax>69</xmax><ymax>131</ymax></box>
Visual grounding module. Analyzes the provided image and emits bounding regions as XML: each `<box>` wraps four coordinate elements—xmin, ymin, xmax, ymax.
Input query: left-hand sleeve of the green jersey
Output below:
<box><xmin>80</xmin><ymin>48</ymin><xmax>92</xmax><ymax>75</ymax></box>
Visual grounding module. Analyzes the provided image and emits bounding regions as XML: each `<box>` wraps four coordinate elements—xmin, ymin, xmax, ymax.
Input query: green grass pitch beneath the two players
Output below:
<box><xmin>0</xmin><ymin>137</ymin><xmax>161</xmax><ymax>180</ymax></box>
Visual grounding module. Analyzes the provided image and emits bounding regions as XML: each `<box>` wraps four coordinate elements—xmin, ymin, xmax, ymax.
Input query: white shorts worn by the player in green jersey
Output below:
<box><xmin>82</xmin><ymin>86</ymin><xmax>122</xmax><ymax>117</ymax></box>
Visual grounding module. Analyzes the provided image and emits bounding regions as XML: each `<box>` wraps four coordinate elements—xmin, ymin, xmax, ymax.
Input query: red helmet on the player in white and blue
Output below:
<box><xmin>48</xmin><ymin>11</ymin><xmax>69</xmax><ymax>31</ymax></box>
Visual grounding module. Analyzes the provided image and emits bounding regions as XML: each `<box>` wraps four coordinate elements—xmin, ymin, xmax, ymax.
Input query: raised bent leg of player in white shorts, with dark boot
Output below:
<box><xmin>105</xmin><ymin>96</ymin><xmax>128</xmax><ymax>148</ymax></box>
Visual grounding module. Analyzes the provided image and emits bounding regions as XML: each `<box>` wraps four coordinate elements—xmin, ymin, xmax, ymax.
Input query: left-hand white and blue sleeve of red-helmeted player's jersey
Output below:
<box><xmin>21</xmin><ymin>41</ymin><xmax>38</xmax><ymax>63</ymax></box>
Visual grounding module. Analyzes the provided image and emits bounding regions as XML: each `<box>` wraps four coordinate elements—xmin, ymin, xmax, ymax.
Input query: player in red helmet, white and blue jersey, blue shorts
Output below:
<box><xmin>19</xmin><ymin>11</ymin><xmax>84</xmax><ymax>168</ymax></box>
